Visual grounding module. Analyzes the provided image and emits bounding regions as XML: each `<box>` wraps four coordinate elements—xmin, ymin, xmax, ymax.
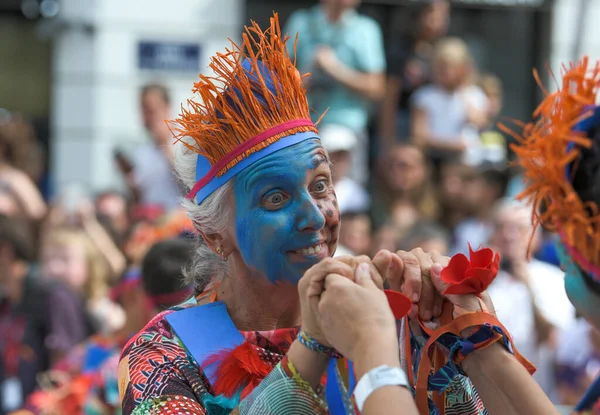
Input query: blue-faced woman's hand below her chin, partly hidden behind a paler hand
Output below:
<box><xmin>298</xmin><ymin>258</ymin><xmax>354</xmax><ymax>347</ymax></box>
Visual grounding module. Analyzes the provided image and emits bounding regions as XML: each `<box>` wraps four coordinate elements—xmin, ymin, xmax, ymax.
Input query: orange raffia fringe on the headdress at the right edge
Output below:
<box><xmin>500</xmin><ymin>57</ymin><xmax>600</xmax><ymax>269</ymax></box>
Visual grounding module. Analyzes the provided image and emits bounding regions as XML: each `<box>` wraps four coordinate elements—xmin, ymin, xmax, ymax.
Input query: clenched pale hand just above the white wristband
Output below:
<box><xmin>318</xmin><ymin>262</ymin><xmax>398</xmax><ymax>361</ymax></box>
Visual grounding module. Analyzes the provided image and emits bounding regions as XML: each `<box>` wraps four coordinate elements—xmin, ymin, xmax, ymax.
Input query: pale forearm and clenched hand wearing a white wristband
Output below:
<box><xmin>318</xmin><ymin>264</ymin><xmax>418</xmax><ymax>415</ymax></box>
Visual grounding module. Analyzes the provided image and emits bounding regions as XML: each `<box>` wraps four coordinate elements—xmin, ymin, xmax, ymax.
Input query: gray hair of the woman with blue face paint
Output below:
<box><xmin>174</xmin><ymin>138</ymin><xmax>232</xmax><ymax>292</ymax></box>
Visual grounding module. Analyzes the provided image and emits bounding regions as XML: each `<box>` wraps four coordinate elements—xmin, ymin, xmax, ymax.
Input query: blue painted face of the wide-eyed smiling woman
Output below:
<box><xmin>234</xmin><ymin>139</ymin><xmax>340</xmax><ymax>284</ymax></box>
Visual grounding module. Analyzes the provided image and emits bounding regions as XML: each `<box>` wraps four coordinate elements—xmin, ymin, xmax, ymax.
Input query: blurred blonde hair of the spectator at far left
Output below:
<box><xmin>42</xmin><ymin>229</ymin><xmax>110</xmax><ymax>300</ymax></box>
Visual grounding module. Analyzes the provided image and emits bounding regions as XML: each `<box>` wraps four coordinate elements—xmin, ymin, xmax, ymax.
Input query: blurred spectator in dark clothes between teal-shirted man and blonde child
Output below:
<box><xmin>379</xmin><ymin>0</ymin><xmax>450</xmax><ymax>146</ymax></box>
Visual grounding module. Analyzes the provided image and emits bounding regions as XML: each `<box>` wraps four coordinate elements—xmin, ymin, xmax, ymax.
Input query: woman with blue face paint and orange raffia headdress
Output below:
<box><xmin>119</xmin><ymin>13</ymin><xmax>492</xmax><ymax>415</ymax></box>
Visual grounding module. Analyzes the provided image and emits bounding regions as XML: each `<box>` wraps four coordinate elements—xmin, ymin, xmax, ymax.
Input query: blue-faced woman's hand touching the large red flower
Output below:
<box><xmin>389</xmin><ymin>248</ymin><xmax>450</xmax><ymax>321</ymax></box>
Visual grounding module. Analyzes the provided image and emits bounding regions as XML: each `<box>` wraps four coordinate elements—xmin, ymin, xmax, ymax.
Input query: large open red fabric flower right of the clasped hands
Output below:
<box><xmin>441</xmin><ymin>245</ymin><xmax>500</xmax><ymax>295</ymax></box>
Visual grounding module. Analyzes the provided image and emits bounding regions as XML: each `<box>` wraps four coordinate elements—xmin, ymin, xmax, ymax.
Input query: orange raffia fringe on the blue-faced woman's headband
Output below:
<box><xmin>169</xmin><ymin>13</ymin><xmax>317</xmax><ymax>176</ymax></box>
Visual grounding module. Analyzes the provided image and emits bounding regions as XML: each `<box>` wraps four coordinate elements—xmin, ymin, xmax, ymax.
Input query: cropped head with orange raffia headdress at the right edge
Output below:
<box><xmin>505</xmin><ymin>58</ymin><xmax>600</xmax><ymax>414</ymax></box>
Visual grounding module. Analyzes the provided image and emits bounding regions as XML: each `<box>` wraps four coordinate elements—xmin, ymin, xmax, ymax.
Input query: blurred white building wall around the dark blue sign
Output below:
<box><xmin>51</xmin><ymin>0</ymin><xmax>244</xmax><ymax>196</ymax></box>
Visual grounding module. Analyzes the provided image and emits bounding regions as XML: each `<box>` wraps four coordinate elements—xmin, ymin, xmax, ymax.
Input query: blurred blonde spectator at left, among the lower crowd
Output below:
<box><xmin>41</xmin><ymin>229</ymin><xmax>125</xmax><ymax>333</ymax></box>
